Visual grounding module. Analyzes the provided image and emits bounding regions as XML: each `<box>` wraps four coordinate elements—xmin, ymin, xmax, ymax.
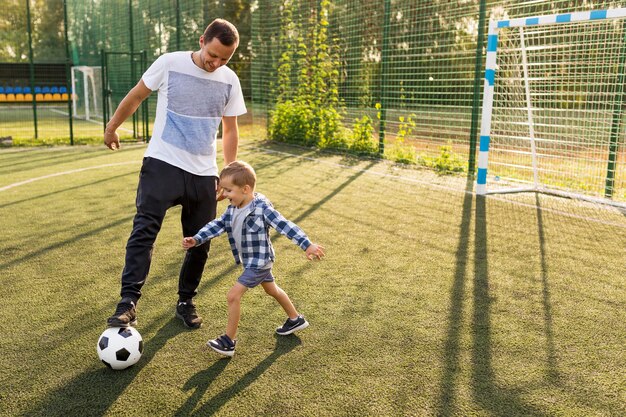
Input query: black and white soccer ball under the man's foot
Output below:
<box><xmin>96</xmin><ymin>327</ymin><xmax>143</xmax><ymax>370</ymax></box>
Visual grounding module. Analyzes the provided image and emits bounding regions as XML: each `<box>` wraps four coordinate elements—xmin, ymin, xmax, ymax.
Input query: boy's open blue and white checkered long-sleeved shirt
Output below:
<box><xmin>193</xmin><ymin>193</ymin><xmax>311</xmax><ymax>268</ymax></box>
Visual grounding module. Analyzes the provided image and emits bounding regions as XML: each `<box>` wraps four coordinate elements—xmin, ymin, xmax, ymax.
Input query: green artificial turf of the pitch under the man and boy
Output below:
<box><xmin>0</xmin><ymin>140</ymin><xmax>626</xmax><ymax>416</ymax></box>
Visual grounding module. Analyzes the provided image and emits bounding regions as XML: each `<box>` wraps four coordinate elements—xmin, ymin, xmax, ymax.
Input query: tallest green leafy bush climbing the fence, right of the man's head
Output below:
<box><xmin>268</xmin><ymin>0</ymin><xmax>347</xmax><ymax>148</ymax></box>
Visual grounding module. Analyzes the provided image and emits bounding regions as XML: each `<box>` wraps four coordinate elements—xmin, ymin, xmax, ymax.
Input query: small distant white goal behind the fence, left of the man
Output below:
<box><xmin>71</xmin><ymin>66</ymin><xmax>103</xmax><ymax>122</ymax></box>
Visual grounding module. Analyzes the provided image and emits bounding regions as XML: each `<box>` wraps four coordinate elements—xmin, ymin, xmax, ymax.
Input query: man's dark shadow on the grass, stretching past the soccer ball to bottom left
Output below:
<box><xmin>22</xmin><ymin>318</ymin><xmax>187</xmax><ymax>416</ymax></box>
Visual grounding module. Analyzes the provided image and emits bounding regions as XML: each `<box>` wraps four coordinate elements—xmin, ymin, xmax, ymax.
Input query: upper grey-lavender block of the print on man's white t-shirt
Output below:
<box><xmin>167</xmin><ymin>71</ymin><xmax>232</xmax><ymax>117</ymax></box>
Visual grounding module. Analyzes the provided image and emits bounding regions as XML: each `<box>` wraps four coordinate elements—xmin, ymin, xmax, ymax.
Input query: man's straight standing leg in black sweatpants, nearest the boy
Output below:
<box><xmin>178</xmin><ymin>173</ymin><xmax>217</xmax><ymax>301</ymax></box>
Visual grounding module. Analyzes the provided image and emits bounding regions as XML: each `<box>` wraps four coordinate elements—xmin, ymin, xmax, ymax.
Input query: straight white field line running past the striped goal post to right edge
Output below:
<box><xmin>243</xmin><ymin>148</ymin><xmax>626</xmax><ymax>229</ymax></box>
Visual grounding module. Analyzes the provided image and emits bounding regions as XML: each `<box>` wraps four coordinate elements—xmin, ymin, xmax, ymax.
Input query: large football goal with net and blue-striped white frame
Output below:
<box><xmin>476</xmin><ymin>8</ymin><xmax>626</xmax><ymax>207</ymax></box>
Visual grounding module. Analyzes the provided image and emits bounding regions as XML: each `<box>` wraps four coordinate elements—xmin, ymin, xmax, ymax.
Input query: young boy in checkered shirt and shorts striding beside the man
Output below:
<box><xmin>183</xmin><ymin>161</ymin><xmax>324</xmax><ymax>356</ymax></box>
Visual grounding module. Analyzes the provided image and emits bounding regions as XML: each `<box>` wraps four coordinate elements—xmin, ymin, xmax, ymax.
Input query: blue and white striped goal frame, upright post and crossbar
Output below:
<box><xmin>476</xmin><ymin>8</ymin><xmax>626</xmax><ymax>195</ymax></box>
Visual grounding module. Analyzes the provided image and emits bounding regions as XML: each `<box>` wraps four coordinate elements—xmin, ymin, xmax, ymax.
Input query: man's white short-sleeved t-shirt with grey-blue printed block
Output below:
<box><xmin>142</xmin><ymin>51</ymin><xmax>246</xmax><ymax>176</ymax></box>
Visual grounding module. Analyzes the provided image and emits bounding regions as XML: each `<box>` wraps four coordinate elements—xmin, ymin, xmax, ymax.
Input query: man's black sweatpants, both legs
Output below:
<box><xmin>121</xmin><ymin>158</ymin><xmax>217</xmax><ymax>300</ymax></box>
